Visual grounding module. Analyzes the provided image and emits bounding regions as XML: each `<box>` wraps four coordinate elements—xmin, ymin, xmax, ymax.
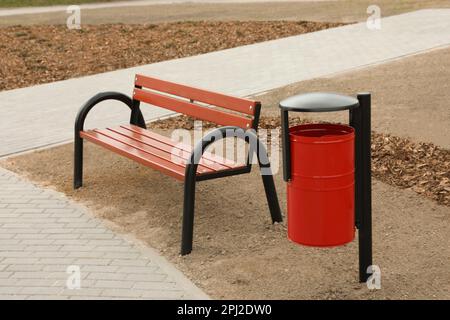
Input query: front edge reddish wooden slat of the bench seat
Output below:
<box><xmin>80</xmin><ymin>131</ymin><xmax>185</xmax><ymax>180</ymax></box>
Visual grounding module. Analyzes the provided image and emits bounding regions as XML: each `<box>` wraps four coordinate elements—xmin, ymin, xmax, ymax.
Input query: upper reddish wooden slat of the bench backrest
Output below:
<box><xmin>135</xmin><ymin>74</ymin><xmax>257</xmax><ymax>115</ymax></box>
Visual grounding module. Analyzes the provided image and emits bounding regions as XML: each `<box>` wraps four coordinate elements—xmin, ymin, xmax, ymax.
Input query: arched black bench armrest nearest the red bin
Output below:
<box><xmin>185</xmin><ymin>126</ymin><xmax>272</xmax><ymax>177</ymax></box>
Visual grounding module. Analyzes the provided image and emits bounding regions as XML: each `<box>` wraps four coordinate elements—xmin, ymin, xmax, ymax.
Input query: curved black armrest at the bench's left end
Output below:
<box><xmin>75</xmin><ymin>91</ymin><xmax>146</xmax><ymax>136</ymax></box>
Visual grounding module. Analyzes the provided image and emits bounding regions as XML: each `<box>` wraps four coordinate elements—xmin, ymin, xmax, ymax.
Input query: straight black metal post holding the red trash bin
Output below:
<box><xmin>354</xmin><ymin>93</ymin><xmax>372</xmax><ymax>282</ymax></box>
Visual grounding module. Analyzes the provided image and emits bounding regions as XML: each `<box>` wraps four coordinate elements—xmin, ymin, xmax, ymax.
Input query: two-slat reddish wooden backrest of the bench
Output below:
<box><xmin>133</xmin><ymin>75</ymin><xmax>261</xmax><ymax>129</ymax></box>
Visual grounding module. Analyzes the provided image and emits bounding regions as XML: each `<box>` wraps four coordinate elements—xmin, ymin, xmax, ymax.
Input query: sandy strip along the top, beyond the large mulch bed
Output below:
<box><xmin>0</xmin><ymin>0</ymin><xmax>450</xmax><ymax>26</ymax></box>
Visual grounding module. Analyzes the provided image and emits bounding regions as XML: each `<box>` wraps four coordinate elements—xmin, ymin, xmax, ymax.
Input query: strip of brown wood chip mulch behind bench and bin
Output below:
<box><xmin>149</xmin><ymin>116</ymin><xmax>450</xmax><ymax>206</ymax></box>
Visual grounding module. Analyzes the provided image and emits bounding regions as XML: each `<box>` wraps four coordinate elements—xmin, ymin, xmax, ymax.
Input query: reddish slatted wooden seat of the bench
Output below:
<box><xmin>80</xmin><ymin>124</ymin><xmax>246</xmax><ymax>180</ymax></box>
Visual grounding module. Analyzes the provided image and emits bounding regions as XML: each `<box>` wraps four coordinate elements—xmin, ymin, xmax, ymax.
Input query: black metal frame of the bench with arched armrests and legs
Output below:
<box><xmin>73</xmin><ymin>78</ymin><xmax>282</xmax><ymax>255</ymax></box>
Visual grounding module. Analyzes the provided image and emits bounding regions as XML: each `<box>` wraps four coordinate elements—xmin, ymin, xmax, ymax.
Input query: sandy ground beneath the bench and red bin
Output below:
<box><xmin>2</xmin><ymin>144</ymin><xmax>450</xmax><ymax>299</ymax></box>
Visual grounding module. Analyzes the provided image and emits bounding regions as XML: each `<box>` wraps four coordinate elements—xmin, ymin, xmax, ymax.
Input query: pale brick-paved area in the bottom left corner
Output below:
<box><xmin>0</xmin><ymin>168</ymin><xmax>208</xmax><ymax>299</ymax></box>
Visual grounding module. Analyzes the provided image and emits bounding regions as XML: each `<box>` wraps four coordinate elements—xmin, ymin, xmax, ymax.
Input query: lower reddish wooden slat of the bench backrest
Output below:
<box><xmin>133</xmin><ymin>89</ymin><xmax>252</xmax><ymax>129</ymax></box>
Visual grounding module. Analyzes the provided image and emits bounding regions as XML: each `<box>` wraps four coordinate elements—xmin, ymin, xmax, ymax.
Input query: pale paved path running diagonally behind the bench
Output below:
<box><xmin>0</xmin><ymin>9</ymin><xmax>450</xmax><ymax>155</ymax></box>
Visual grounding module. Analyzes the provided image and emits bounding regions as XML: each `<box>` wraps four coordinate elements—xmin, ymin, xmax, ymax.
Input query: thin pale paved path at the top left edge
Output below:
<box><xmin>0</xmin><ymin>0</ymin><xmax>326</xmax><ymax>17</ymax></box>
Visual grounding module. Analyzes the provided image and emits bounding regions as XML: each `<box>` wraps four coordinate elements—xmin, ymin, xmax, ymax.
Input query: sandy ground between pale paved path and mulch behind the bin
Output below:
<box><xmin>257</xmin><ymin>47</ymin><xmax>450</xmax><ymax>149</ymax></box>
